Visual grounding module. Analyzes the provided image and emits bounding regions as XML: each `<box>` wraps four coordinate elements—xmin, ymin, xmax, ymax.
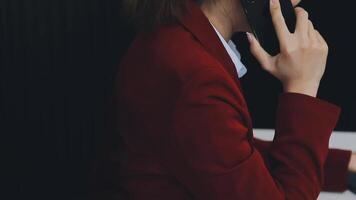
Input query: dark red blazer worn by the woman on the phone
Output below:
<box><xmin>116</xmin><ymin>3</ymin><xmax>350</xmax><ymax>200</ymax></box>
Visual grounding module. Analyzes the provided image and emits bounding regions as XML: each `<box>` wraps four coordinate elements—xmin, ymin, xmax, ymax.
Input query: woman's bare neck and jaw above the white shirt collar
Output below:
<box><xmin>201</xmin><ymin>1</ymin><xmax>234</xmax><ymax>41</ymax></box>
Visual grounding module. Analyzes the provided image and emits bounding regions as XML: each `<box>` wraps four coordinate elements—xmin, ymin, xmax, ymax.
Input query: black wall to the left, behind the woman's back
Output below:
<box><xmin>0</xmin><ymin>0</ymin><xmax>131</xmax><ymax>199</ymax></box>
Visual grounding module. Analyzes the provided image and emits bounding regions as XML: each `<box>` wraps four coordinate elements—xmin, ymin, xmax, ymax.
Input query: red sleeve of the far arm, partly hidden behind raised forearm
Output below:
<box><xmin>254</xmin><ymin>138</ymin><xmax>352</xmax><ymax>192</ymax></box>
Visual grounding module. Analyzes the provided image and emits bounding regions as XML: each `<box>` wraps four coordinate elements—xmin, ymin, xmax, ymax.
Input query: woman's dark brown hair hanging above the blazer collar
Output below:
<box><xmin>123</xmin><ymin>0</ymin><xmax>206</xmax><ymax>29</ymax></box>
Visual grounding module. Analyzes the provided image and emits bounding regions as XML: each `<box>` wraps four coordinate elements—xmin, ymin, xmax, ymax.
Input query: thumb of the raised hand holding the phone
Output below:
<box><xmin>246</xmin><ymin>32</ymin><xmax>274</xmax><ymax>71</ymax></box>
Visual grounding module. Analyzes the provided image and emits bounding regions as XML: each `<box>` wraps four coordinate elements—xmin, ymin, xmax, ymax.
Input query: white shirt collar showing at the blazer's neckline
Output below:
<box><xmin>211</xmin><ymin>24</ymin><xmax>247</xmax><ymax>78</ymax></box>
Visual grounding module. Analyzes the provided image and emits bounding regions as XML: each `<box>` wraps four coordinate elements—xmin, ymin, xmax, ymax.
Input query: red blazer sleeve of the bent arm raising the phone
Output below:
<box><xmin>161</xmin><ymin>69</ymin><xmax>340</xmax><ymax>200</ymax></box>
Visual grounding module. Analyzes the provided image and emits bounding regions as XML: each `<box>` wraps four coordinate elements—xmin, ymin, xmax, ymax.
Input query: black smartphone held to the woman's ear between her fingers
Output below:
<box><xmin>241</xmin><ymin>0</ymin><xmax>296</xmax><ymax>55</ymax></box>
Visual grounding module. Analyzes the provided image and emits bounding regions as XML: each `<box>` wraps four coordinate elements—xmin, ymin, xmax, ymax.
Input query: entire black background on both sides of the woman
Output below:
<box><xmin>0</xmin><ymin>0</ymin><xmax>356</xmax><ymax>199</ymax></box>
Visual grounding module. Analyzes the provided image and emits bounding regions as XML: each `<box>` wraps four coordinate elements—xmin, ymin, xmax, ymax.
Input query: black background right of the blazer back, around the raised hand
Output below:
<box><xmin>234</xmin><ymin>0</ymin><xmax>356</xmax><ymax>131</ymax></box>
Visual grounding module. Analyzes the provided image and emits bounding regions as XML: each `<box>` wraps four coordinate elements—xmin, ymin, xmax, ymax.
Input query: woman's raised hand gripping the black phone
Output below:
<box><xmin>247</xmin><ymin>0</ymin><xmax>328</xmax><ymax>97</ymax></box>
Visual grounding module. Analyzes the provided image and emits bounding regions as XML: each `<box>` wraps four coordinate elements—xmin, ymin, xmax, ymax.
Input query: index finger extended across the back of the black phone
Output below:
<box><xmin>270</xmin><ymin>0</ymin><xmax>291</xmax><ymax>46</ymax></box>
